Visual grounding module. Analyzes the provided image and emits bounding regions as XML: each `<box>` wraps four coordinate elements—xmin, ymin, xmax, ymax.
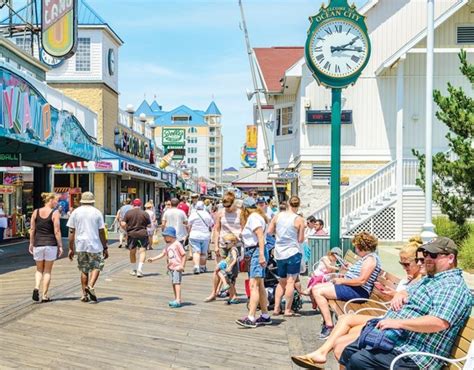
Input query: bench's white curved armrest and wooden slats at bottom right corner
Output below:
<box><xmin>390</xmin><ymin>317</ymin><xmax>474</xmax><ymax>370</ymax></box>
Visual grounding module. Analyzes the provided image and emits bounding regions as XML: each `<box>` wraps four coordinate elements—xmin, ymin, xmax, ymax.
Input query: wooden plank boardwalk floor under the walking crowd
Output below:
<box><xmin>0</xmin><ymin>241</ymin><xmax>337</xmax><ymax>369</ymax></box>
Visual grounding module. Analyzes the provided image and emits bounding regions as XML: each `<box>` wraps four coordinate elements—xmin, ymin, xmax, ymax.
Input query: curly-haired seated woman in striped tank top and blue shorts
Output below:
<box><xmin>311</xmin><ymin>231</ymin><xmax>381</xmax><ymax>339</ymax></box>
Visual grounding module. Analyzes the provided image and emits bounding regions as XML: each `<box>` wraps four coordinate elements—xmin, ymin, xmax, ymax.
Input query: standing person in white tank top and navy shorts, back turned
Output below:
<box><xmin>268</xmin><ymin>196</ymin><xmax>305</xmax><ymax>316</ymax></box>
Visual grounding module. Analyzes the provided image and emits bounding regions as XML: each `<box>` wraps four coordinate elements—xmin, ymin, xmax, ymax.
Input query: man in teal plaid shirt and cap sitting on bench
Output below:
<box><xmin>339</xmin><ymin>237</ymin><xmax>472</xmax><ymax>370</ymax></box>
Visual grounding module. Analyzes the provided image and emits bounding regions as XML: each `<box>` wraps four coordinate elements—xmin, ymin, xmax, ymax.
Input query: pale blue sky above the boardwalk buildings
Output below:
<box><xmin>11</xmin><ymin>0</ymin><xmax>365</xmax><ymax>168</ymax></box>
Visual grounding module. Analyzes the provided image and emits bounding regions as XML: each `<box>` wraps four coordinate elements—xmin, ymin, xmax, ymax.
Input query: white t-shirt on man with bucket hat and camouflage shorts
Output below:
<box><xmin>67</xmin><ymin>205</ymin><xmax>105</xmax><ymax>253</ymax></box>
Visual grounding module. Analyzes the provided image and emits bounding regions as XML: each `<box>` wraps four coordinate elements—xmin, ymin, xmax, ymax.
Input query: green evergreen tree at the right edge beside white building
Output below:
<box><xmin>413</xmin><ymin>50</ymin><xmax>474</xmax><ymax>228</ymax></box>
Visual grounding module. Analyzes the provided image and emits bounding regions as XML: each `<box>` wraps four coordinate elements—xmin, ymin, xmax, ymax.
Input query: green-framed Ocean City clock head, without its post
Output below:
<box><xmin>305</xmin><ymin>0</ymin><xmax>370</xmax><ymax>88</ymax></box>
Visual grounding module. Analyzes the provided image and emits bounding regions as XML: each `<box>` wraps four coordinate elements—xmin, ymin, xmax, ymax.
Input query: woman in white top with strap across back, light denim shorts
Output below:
<box><xmin>188</xmin><ymin>201</ymin><xmax>214</xmax><ymax>274</ymax></box>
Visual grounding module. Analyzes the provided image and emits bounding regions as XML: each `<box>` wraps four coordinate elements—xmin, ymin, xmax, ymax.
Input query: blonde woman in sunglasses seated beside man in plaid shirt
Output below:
<box><xmin>291</xmin><ymin>239</ymin><xmax>426</xmax><ymax>369</ymax></box>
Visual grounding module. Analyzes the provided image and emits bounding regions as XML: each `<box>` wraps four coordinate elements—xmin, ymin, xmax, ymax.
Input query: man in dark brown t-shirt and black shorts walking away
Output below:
<box><xmin>122</xmin><ymin>199</ymin><xmax>151</xmax><ymax>277</ymax></box>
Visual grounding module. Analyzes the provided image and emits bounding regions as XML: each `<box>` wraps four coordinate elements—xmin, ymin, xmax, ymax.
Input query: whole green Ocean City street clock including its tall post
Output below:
<box><xmin>305</xmin><ymin>0</ymin><xmax>370</xmax><ymax>247</ymax></box>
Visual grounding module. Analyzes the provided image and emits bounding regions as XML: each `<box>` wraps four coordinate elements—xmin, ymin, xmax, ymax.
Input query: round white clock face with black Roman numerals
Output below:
<box><xmin>309</xmin><ymin>20</ymin><xmax>368</xmax><ymax>78</ymax></box>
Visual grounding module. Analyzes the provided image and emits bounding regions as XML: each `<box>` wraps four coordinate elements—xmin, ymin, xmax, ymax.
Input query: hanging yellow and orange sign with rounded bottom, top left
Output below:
<box><xmin>41</xmin><ymin>0</ymin><xmax>77</xmax><ymax>58</ymax></box>
